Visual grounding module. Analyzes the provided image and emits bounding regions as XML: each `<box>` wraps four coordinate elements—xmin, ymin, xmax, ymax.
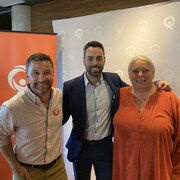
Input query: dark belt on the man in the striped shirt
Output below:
<box><xmin>19</xmin><ymin>155</ymin><xmax>61</xmax><ymax>170</ymax></box>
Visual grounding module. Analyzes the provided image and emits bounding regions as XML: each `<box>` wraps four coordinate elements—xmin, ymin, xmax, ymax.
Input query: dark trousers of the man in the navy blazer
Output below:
<box><xmin>73</xmin><ymin>137</ymin><xmax>113</xmax><ymax>180</ymax></box>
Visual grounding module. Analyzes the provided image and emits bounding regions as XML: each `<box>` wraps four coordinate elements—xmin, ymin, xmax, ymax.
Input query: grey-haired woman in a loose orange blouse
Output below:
<box><xmin>113</xmin><ymin>56</ymin><xmax>180</xmax><ymax>180</ymax></box>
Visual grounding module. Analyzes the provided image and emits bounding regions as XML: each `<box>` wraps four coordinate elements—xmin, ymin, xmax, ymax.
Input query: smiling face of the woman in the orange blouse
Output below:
<box><xmin>129</xmin><ymin>59</ymin><xmax>155</xmax><ymax>90</ymax></box>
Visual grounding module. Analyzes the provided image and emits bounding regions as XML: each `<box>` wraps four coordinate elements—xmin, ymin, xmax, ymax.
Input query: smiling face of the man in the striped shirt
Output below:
<box><xmin>27</xmin><ymin>61</ymin><xmax>54</xmax><ymax>96</ymax></box>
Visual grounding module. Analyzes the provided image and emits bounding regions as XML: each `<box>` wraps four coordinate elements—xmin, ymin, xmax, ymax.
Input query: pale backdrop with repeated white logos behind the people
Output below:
<box><xmin>53</xmin><ymin>2</ymin><xmax>180</xmax><ymax>180</ymax></box>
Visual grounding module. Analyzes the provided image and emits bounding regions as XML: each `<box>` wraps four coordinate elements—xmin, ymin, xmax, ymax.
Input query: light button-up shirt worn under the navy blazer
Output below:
<box><xmin>84</xmin><ymin>73</ymin><xmax>112</xmax><ymax>140</ymax></box>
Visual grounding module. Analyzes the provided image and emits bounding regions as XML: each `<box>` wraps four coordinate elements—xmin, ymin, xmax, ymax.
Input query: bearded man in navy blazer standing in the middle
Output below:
<box><xmin>63</xmin><ymin>41</ymin><xmax>168</xmax><ymax>180</ymax></box>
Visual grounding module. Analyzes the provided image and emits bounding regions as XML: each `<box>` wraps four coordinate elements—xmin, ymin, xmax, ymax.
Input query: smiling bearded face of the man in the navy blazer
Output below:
<box><xmin>83</xmin><ymin>47</ymin><xmax>105</xmax><ymax>78</ymax></box>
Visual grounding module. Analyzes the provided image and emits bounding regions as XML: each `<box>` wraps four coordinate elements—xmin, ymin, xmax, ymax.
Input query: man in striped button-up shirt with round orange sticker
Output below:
<box><xmin>0</xmin><ymin>53</ymin><xmax>67</xmax><ymax>180</ymax></box>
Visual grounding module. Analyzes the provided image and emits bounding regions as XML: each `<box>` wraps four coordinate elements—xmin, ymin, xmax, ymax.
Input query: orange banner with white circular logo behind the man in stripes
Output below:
<box><xmin>0</xmin><ymin>32</ymin><xmax>56</xmax><ymax>180</ymax></box>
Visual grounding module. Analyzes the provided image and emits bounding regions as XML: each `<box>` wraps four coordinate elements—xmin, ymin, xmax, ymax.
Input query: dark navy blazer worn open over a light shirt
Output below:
<box><xmin>63</xmin><ymin>72</ymin><xmax>127</xmax><ymax>161</ymax></box>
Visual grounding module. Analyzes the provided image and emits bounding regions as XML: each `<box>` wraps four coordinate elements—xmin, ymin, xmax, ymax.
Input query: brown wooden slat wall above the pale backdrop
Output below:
<box><xmin>31</xmin><ymin>0</ymin><xmax>169</xmax><ymax>33</ymax></box>
